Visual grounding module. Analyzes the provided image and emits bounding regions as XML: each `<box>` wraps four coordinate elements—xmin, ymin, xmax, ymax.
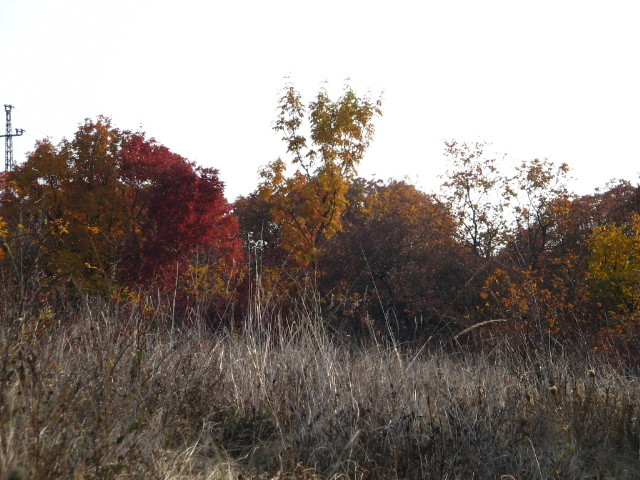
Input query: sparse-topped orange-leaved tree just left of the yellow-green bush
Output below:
<box><xmin>483</xmin><ymin>159</ymin><xmax>583</xmax><ymax>337</ymax></box>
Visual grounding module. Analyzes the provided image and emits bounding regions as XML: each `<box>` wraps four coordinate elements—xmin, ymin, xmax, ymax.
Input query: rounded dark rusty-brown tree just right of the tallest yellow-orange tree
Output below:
<box><xmin>322</xmin><ymin>179</ymin><xmax>473</xmax><ymax>339</ymax></box>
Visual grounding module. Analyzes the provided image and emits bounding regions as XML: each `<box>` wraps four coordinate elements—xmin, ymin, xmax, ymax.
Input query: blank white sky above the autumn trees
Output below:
<box><xmin>0</xmin><ymin>0</ymin><xmax>640</xmax><ymax>200</ymax></box>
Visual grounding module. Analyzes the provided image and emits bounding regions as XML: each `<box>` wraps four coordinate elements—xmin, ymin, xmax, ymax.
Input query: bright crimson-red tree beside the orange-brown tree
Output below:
<box><xmin>118</xmin><ymin>134</ymin><xmax>243</xmax><ymax>282</ymax></box>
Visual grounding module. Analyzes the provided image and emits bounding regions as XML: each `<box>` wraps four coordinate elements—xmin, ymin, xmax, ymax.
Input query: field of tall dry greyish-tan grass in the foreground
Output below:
<box><xmin>0</xmin><ymin>301</ymin><xmax>640</xmax><ymax>480</ymax></box>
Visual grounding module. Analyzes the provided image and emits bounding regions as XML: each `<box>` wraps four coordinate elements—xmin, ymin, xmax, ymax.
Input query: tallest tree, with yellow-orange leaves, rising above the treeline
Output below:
<box><xmin>258</xmin><ymin>85</ymin><xmax>381</xmax><ymax>265</ymax></box>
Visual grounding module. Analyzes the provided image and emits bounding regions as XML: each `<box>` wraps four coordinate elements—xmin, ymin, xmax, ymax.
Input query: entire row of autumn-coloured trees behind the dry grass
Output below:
<box><xmin>0</xmin><ymin>86</ymin><xmax>640</xmax><ymax>352</ymax></box>
